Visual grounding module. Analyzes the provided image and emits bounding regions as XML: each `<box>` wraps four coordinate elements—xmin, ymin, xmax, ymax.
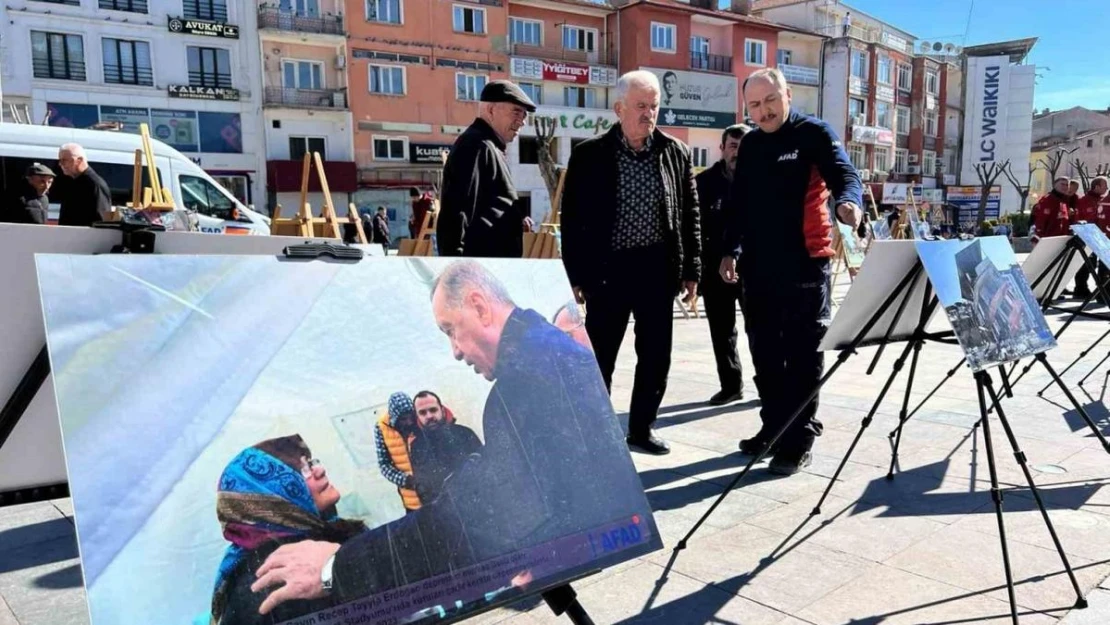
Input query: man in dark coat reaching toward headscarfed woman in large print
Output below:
<box><xmin>252</xmin><ymin>260</ymin><xmax>656</xmax><ymax>613</ymax></box>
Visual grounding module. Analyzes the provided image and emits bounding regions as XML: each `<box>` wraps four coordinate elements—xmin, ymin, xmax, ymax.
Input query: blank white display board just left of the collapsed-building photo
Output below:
<box><xmin>820</xmin><ymin>239</ymin><xmax>927</xmax><ymax>352</ymax></box>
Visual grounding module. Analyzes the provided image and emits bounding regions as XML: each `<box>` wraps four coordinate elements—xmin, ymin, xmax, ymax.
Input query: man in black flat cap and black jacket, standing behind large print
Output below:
<box><xmin>435</xmin><ymin>80</ymin><xmax>536</xmax><ymax>259</ymax></box>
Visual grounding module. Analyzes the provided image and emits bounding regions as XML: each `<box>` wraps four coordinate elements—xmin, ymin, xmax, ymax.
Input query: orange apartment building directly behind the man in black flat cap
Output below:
<box><xmin>346</xmin><ymin>0</ymin><xmax>508</xmax><ymax>225</ymax></box>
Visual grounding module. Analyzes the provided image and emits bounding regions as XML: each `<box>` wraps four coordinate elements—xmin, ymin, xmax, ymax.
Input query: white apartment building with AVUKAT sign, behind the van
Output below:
<box><xmin>0</xmin><ymin>0</ymin><xmax>265</xmax><ymax>206</ymax></box>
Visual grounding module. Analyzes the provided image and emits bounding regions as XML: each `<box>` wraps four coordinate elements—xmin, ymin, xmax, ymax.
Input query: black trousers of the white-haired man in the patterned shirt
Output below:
<box><xmin>586</xmin><ymin>245</ymin><xmax>677</xmax><ymax>438</ymax></box>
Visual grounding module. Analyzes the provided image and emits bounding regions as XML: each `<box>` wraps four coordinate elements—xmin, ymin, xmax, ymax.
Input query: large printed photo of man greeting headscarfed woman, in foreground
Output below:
<box><xmin>37</xmin><ymin>255</ymin><xmax>662</xmax><ymax>625</ymax></box>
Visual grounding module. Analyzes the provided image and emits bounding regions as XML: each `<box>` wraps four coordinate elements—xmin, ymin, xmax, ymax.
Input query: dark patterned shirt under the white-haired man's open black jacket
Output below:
<box><xmin>613</xmin><ymin>134</ymin><xmax>664</xmax><ymax>250</ymax></box>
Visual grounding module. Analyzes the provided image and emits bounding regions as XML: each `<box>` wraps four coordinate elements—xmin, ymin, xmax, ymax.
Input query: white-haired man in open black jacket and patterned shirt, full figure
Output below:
<box><xmin>561</xmin><ymin>71</ymin><xmax>702</xmax><ymax>455</ymax></box>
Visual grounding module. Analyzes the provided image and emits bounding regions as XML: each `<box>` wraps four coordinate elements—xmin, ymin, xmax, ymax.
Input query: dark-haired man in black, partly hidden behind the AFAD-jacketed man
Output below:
<box><xmin>695</xmin><ymin>123</ymin><xmax>750</xmax><ymax>405</ymax></box>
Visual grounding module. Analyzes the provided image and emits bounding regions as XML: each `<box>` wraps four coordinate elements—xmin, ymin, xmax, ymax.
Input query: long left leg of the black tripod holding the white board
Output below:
<box><xmin>675</xmin><ymin>261</ymin><xmax>925</xmax><ymax>553</ymax></box>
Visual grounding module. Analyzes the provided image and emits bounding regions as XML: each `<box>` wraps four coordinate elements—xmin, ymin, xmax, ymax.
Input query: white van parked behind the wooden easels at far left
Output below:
<box><xmin>0</xmin><ymin>123</ymin><xmax>270</xmax><ymax>234</ymax></box>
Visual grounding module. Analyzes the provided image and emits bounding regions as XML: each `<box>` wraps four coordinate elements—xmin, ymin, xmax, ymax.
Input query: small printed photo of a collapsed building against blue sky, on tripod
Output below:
<box><xmin>916</xmin><ymin>236</ymin><xmax>1056</xmax><ymax>372</ymax></box>
